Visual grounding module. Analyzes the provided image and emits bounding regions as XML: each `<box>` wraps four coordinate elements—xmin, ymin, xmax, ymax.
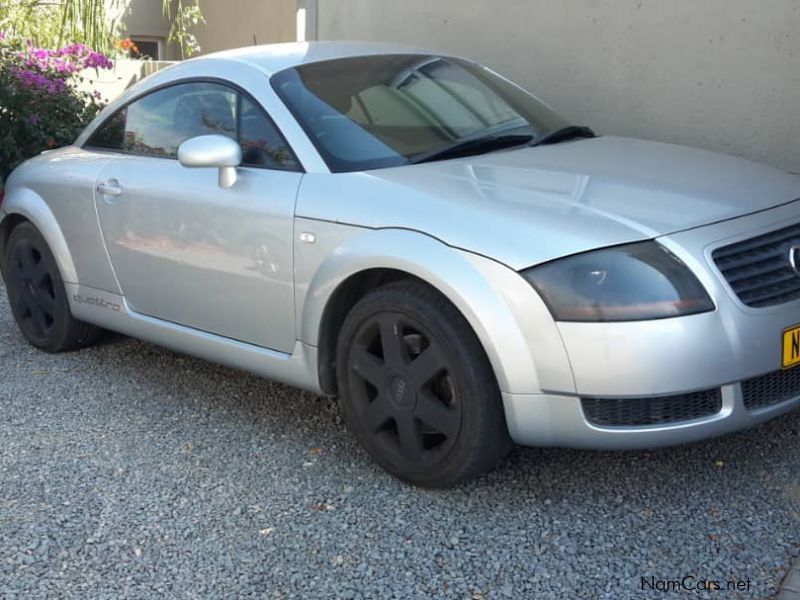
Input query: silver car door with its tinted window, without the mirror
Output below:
<box><xmin>88</xmin><ymin>82</ymin><xmax>302</xmax><ymax>353</ymax></box>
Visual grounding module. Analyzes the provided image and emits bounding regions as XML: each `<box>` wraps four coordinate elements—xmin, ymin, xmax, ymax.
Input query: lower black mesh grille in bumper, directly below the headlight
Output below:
<box><xmin>581</xmin><ymin>388</ymin><xmax>722</xmax><ymax>427</ymax></box>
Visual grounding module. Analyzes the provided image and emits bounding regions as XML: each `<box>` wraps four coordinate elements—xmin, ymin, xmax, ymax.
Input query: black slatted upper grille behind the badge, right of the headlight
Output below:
<box><xmin>712</xmin><ymin>224</ymin><xmax>800</xmax><ymax>308</ymax></box>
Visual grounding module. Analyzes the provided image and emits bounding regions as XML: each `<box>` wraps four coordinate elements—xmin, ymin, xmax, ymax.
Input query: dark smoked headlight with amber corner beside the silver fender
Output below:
<box><xmin>522</xmin><ymin>242</ymin><xmax>714</xmax><ymax>322</ymax></box>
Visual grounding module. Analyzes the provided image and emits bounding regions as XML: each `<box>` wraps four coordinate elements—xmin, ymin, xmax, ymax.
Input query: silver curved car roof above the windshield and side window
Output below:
<box><xmin>195</xmin><ymin>42</ymin><xmax>442</xmax><ymax>75</ymax></box>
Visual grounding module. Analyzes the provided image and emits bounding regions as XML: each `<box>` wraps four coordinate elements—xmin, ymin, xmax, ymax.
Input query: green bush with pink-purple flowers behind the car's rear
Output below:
<box><xmin>0</xmin><ymin>32</ymin><xmax>113</xmax><ymax>187</ymax></box>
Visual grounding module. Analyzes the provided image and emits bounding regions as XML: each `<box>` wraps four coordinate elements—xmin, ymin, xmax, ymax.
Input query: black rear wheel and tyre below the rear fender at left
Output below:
<box><xmin>3</xmin><ymin>223</ymin><xmax>100</xmax><ymax>352</ymax></box>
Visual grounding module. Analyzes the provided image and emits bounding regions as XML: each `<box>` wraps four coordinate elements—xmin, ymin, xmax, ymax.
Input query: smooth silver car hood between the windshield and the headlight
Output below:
<box><xmin>298</xmin><ymin>137</ymin><xmax>800</xmax><ymax>269</ymax></box>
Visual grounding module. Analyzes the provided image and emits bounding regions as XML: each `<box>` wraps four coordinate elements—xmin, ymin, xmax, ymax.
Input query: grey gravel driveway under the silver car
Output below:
<box><xmin>0</xmin><ymin>286</ymin><xmax>800</xmax><ymax>598</ymax></box>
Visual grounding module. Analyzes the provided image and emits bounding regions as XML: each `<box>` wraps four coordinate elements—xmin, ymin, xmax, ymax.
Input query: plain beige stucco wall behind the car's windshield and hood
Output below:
<box><xmin>316</xmin><ymin>0</ymin><xmax>800</xmax><ymax>172</ymax></box>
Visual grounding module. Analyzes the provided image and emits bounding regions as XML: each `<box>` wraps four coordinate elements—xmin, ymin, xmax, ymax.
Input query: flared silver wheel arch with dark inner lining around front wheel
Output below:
<box><xmin>300</xmin><ymin>229</ymin><xmax>573</xmax><ymax>394</ymax></box>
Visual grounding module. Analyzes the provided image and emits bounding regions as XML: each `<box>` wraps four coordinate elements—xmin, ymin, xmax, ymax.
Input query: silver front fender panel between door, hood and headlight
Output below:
<box><xmin>297</xmin><ymin>222</ymin><xmax>575</xmax><ymax>393</ymax></box>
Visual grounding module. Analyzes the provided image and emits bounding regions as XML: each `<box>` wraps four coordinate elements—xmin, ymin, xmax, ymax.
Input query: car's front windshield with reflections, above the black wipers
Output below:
<box><xmin>272</xmin><ymin>54</ymin><xmax>569</xmax><ymax>173</ymax></box>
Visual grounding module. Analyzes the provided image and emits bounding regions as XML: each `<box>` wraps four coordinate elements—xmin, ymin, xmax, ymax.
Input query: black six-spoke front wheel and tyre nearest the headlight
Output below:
<box><xmin>336</xmin><ymin>281</ymin><xmax>511</xmax><ymax>487</ymax></box>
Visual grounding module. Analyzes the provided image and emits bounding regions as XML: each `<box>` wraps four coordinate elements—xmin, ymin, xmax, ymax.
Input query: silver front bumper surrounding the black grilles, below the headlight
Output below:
<box><xmin>510</xmin><ymin>202</ymin><xmax>800</xmax><ymax>449</ymax></box>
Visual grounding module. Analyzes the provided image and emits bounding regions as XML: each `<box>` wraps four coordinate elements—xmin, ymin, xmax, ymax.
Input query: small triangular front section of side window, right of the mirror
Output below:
<box><xmin>239</xmin><ymin>96</ymin><xmax>300</xmax><ymax>171</ymax></box>
